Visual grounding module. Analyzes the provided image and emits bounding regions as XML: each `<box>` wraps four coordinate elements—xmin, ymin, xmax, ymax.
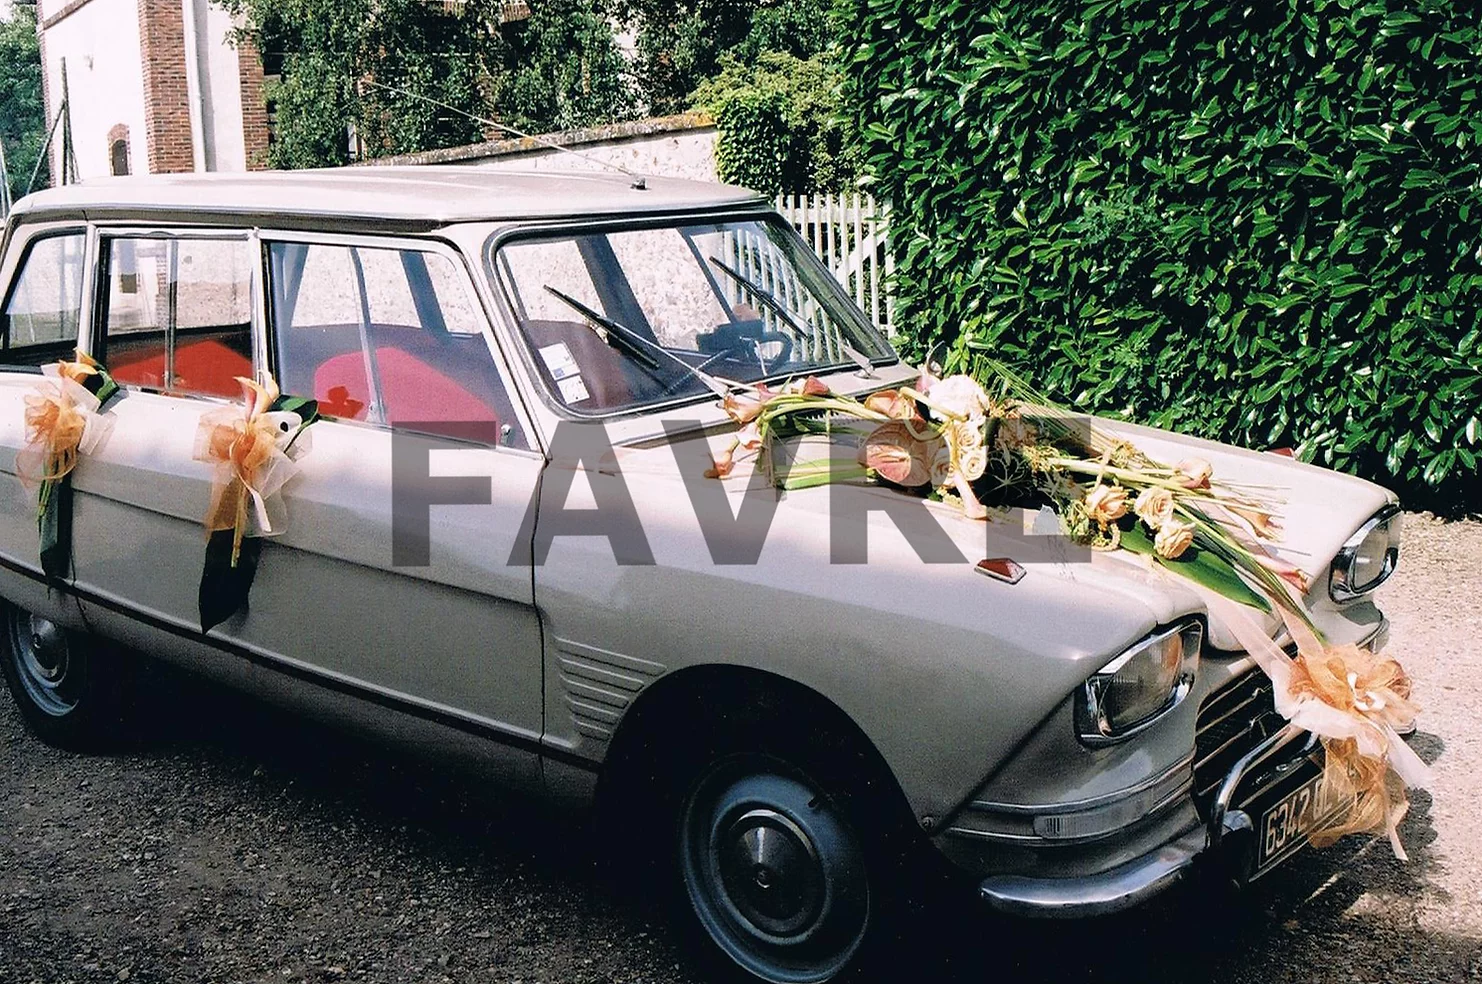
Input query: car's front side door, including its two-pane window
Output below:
<box><xmin>225</xmin><ymin>233</ymin><xmax>557</xmax><ymax>751</ymax></box>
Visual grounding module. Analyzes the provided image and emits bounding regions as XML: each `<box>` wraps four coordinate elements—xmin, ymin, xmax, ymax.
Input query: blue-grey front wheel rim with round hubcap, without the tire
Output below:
<box><xmin>679</xmin><ymin>757</ymin><xmax>877</xmax><ymax>984</ymax></box>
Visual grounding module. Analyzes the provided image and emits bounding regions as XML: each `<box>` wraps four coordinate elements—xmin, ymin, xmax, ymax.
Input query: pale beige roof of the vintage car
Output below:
<box><xmin>15</xmin><ymin>164</ymin><xmax>765</xmax><ymax>227</ymax></box>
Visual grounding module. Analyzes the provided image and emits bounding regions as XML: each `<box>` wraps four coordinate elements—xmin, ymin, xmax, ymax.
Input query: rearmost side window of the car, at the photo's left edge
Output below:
<box><xmin>0</xmin><ymin>233</ymin><xmax>84</xmax><ymax>365</ymax></box>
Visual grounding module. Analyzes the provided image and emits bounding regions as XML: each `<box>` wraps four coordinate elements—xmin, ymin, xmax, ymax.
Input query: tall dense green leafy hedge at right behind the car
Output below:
<box><xmin>837</xmin><ymin>0</ymin><xmax>1482</xmax><ymax>511</ymax></box>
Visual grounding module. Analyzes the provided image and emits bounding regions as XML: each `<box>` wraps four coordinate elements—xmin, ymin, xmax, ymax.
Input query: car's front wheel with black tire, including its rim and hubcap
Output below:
<box><xmin>628</xmin><ymin>684</ymin><xmax>917</xmax><ymax>984</ymax></box>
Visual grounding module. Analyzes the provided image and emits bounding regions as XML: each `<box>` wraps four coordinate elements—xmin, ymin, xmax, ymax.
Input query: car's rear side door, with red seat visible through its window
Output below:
<box><xmin>73</xmin><ymin>227</ymin><xmax>269</xmax><ymax>655</ymax></box>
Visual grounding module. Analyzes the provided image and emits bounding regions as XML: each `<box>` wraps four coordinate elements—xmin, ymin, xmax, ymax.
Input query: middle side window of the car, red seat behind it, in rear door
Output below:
<box><xmin>101</xmin><ymin>237</ymin><xmax>253</xmax><ymax>397</ymax></box>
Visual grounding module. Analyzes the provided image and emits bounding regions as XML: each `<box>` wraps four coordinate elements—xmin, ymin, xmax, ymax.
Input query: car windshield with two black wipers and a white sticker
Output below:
<box><xmin>494</xmin><ymin>219</ymin><xmax>892</xmax><ymax>413</ymax></box>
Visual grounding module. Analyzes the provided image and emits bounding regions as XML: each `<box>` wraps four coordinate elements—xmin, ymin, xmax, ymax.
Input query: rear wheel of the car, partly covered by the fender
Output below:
<box><xmin>0</xmin><ymin>602</ymin><xmax>130</xmax><ymax>751</ymax></box>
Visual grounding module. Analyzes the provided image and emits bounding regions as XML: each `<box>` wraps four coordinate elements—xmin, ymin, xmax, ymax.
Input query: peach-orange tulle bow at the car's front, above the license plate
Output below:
<box><xmin>1206</xmin><ymin>599</ymin><xmax>1430</xmax><ymax>860</ymax></box>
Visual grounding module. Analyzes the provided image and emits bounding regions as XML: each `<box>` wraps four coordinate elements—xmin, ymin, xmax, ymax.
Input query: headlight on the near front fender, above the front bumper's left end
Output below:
<box><xmin>1076</xmin><ymin>621</ymin><xmax>1203</xmax><ymax>745</ymax></box>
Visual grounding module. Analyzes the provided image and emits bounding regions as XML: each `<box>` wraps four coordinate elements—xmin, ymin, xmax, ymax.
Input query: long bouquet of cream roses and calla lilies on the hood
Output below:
<box><xmin>707</xmin><ymin>369</ymin><xmax>1306</xmax><ymax>612</ymax></box>
